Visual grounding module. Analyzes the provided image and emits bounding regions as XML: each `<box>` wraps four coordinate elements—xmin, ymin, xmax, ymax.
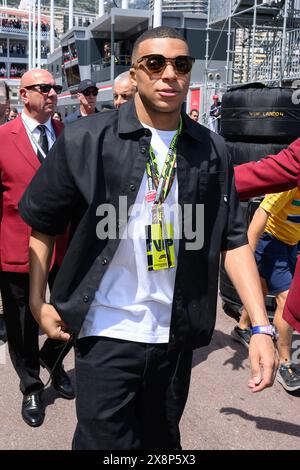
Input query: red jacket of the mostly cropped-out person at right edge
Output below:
<box><xmin>235</xmin><ymin>139</ymin><xmax>300</xmax><ymax>332</ymax></box>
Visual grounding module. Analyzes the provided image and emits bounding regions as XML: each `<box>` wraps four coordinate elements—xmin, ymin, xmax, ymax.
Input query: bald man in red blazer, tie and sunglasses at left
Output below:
<box><xmin>0</xmin><ymin>69</ymin><xmax>74</xmax><ymax>426</ymax></box>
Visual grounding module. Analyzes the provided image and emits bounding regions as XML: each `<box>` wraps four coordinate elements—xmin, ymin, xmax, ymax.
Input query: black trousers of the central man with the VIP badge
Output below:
<box><xmin>73</xmin><ymin>337</ymin><xmax>192</xmax><ymax>450</ymax></box>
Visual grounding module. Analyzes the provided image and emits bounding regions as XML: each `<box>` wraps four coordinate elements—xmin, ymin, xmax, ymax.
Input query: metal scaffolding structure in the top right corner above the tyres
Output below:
<box><xmin>205</xmin><ymin>0</ymin><xmax>300</xmax><ymax>88</ymax></box>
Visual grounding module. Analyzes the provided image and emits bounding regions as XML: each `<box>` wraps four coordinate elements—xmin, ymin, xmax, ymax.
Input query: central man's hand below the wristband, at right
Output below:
<box><xmin>248</xmin><ymin>334</ymin><xmax>279</xmax><ymax>393</ymax></box>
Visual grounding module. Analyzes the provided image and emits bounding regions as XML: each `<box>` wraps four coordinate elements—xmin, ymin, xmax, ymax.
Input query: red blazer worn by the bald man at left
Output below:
<box><xmin>0</xmin><ymin>116</ymin><xmax>63</xmax><ymax>273</ymax></box>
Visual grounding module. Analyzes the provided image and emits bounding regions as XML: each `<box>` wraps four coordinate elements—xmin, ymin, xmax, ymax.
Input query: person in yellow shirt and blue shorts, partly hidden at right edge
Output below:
<box><xmin>231</xmin><ymin>188</ymin><xmax>300</xmax><ymax>391</ymax></box>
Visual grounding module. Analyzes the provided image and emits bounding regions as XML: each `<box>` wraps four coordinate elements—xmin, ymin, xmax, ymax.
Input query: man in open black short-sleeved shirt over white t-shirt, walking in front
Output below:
<box><xmin>20</xmin><ymin>27</ymin><xmax>276</xmax><ymax>450</ymax></box>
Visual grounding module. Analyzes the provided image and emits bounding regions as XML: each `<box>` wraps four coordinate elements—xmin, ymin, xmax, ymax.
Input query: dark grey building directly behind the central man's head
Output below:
<box><xmin>48</xmin><ymin>8</ymin><xmax>227</xmax><ymax>116</ymax></box>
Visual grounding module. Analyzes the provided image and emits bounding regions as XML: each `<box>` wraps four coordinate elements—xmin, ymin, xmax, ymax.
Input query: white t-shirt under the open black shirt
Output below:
<box><xmin>79</xmin><ymin>125</ymin><xmax>179</xmax><ymax>343</ymax></box>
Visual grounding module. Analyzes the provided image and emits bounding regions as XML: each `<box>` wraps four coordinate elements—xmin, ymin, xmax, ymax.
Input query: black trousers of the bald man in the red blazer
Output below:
<box><xmin>0</xmin><ymin>272</ymin><xmax>72</xmax><ymax>395</ymax></box>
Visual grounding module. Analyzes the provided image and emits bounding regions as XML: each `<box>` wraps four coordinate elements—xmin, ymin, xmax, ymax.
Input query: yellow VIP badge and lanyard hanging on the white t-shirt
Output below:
<box><xmin>145</xmin><ymin>118</ymin><xmax>182</xmax><ymax>271</ymax></box>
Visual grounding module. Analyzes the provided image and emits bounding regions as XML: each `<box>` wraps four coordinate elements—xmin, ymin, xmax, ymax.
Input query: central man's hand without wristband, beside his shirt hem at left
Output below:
<box><xmin>32</xmin><ymin>303</ymin><xmax>71</xmax><ymax>341</ymax></box>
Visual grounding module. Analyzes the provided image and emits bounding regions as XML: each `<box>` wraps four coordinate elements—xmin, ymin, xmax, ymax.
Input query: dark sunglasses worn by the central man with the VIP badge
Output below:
<box><xmin>137</xmin><ymin>54</ymin><xmax>195</xmax><ymax>75</ymax></box>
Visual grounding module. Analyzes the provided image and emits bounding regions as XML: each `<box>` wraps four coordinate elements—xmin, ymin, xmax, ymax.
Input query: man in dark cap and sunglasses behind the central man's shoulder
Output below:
<box><xmin>64</xmin><ymin>80</ymin><xmax>99</xmax><ymax>124</ymax></box>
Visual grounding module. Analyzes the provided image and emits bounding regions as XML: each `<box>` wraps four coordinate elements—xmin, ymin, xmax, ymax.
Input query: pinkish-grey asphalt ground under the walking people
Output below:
<box><xmin>0</xmin><ymin>303</ymin><xmax>300</xmax><ymax>450</ymax></box>
